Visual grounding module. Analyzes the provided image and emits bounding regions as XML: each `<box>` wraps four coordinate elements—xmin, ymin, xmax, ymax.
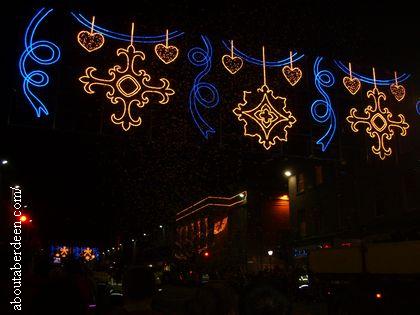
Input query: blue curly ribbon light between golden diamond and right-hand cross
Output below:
<box><xmin>311</xmin><ymin>57</ymin><xmax>337</xmax><ymax>152</ymax></box>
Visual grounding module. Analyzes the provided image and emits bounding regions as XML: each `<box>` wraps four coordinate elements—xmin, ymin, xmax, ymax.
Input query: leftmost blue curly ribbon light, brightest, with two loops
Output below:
<box><xmin>19</xmin><ymin>8</ymin><xmax>61</xmax><ymax>117</ymax></box>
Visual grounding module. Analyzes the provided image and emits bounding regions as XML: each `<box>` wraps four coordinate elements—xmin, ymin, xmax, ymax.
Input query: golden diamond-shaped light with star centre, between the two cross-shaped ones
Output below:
<box><xmin>233</xmin><ymin>46</ymin><xmax>296</xmax><ymax>150</ymax></box>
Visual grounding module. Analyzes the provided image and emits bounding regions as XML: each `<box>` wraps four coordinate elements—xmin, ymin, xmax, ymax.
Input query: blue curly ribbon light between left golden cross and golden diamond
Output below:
<box><xmin>188</xmin><ymin>35</ymin><xmax>220</xmax><ymax>139</ymax></box>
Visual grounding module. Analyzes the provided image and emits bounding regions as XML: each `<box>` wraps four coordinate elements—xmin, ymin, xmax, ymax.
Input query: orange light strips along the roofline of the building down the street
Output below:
<box><xmin>175</xmin><ymin>191</ymin><xmax>248</xmax><ymax>221</ymax></box>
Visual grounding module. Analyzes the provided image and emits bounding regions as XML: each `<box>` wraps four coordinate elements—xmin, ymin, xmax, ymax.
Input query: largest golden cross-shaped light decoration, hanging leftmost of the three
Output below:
<box><xmin>79</xmin><ymin>25</ymin><xmax>175</xmax><ymax>131</ymax></box>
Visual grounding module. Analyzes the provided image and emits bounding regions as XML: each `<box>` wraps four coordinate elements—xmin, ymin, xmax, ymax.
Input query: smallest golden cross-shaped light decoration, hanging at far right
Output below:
<box><xmin>346</xmin><ymin>69</ymin><xmax>409</xmax><ymax>160</ymax></box>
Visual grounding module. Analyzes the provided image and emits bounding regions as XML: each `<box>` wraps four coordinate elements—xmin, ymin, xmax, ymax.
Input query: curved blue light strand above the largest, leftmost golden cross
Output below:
<box><xmin>70</xmin><ymin>12</ymin><xmax>185</xmax><ymax>44</ymax></box>
